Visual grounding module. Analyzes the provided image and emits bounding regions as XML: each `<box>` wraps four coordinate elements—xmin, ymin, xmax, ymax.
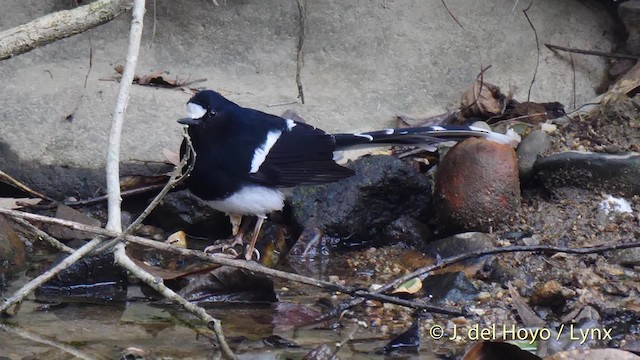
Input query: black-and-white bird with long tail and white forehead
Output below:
<box><xmin>178</xmin><ymin>90</ymin><xmax>514</xmax><ymax>260</ymax></box>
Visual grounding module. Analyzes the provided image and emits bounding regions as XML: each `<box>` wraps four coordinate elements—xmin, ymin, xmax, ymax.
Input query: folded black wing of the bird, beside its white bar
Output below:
<box><xmin>249</xmin><ymin>122</ymin><xmax>353</xmax><ymax>187</ymax></box>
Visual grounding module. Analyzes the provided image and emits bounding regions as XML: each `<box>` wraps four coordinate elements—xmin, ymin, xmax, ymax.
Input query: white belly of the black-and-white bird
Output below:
<box><xmin>207</xmin><ymin>185</ymin><xmax>284</xmax><ymax>217</ymax></box>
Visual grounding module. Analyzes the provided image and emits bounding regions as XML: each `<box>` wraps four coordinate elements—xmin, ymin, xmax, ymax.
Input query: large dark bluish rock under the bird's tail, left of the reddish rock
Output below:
<box><xmin>291</xmin><ymin>156</ymin><xmax>431</xmax><ymax>246</ymax></box>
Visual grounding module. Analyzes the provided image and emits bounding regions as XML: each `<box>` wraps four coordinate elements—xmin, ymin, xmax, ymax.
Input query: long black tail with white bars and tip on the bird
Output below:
<box><xmin>332</xmin><ymin>125</ymin><xmax>520</xmax><ymax>151</ymax></box>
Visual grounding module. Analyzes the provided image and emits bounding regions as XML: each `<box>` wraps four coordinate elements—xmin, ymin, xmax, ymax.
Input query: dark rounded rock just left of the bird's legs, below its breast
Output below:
<box><xmin>146</xmin><ymin>190</ymin><xmax>231</xmax><ymax>239</ymax></box>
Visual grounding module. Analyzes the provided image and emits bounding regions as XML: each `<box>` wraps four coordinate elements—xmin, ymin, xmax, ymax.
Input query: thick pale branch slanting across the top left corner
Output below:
<box><xmin>0</xmin><ymin>0</ymin><xmax>131</xmax><ymax>60</ymax></box>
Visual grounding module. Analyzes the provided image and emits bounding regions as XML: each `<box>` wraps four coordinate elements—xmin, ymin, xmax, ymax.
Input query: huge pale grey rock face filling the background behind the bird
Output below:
<box><xmin>0</xmin><ymin>0</ymin><xmax>611</xmax><ymax>196</ymax></box>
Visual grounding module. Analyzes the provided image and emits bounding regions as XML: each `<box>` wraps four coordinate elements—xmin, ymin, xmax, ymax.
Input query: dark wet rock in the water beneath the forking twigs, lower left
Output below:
<box><xmin>35</xmin><ymin>253</ymin><xmax>128</xmax><ymax>303</ymax></box>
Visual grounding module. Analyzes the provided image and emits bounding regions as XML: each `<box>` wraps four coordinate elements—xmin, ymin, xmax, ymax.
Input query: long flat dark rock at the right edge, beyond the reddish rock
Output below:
<box><xmin>533</xmin><ymin>151</ymin><xmax>640</xmax><ymax>196</ymax></box>
